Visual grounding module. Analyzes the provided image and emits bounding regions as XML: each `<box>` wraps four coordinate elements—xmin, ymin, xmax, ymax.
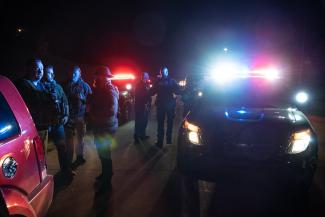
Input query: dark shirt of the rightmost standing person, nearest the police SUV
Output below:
<box><xmin>150</xmin><ymin>77</ymin><xmax>180</xmax><ymax>108</ymax></box>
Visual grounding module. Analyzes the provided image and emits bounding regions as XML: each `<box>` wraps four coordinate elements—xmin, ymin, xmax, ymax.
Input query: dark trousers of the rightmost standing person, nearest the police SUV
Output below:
<box><xmin>157</xmin><ymin>106</ymin><xmax>175</xmax><ymax>144</ymax></box>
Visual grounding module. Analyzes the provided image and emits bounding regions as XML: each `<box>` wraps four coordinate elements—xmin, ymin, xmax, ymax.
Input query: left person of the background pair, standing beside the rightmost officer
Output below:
<box><xmin>134</xmin><ymin>72</ymin><xmax>151</xmax><ymax>144</ymax></box>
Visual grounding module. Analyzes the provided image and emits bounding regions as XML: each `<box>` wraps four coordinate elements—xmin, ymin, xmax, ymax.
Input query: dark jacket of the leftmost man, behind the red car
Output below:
<box><xmin>15</xmin><ymin>78</ymin><xmax>55</xmax><ymax>130</ymax></box>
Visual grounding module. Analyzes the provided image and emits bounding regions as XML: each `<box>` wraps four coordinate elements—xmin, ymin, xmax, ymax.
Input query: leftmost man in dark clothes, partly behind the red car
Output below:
<box><xmin>15</xmin><ymin>58</ymin><xmax>55</xmax><ymax>159</ymax></box>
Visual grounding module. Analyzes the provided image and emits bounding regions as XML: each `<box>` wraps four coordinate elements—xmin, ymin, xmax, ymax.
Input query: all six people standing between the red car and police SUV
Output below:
<box><xmin>15</xmin><ymin>59</ymin><xmax>180</xmax><ymax>193</ymax></box>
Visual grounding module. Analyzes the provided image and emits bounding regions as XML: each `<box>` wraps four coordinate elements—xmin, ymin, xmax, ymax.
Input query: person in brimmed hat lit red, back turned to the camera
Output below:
<box><xmin>90</xmin><ymin>66</ymin><xmax>119</xmax><ymax>193</ymax></box>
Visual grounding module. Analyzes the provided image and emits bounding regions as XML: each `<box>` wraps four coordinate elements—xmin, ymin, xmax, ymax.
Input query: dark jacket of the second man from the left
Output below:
<box><xmin>43</xmin><ymin>80</ymin><xmax>69</xmax><ymax>123</ymax></box>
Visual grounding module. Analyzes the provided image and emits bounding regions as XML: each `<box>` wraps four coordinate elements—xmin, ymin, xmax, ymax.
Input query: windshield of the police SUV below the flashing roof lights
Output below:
<box><xmin>202</xmin><ymin>81</ymin><xmax>292</xmax><ymax>108</ymax></box>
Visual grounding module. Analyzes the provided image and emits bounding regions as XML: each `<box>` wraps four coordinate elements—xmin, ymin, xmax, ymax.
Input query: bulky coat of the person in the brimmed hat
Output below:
<box><xmin>90</xmin><ymin>84</ymin><xmax>119</xmax><ymax>133</ymax></box>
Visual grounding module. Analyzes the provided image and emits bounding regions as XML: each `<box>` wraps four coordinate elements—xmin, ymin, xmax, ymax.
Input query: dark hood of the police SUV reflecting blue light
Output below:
<box><xmin>187</xmin><ymin>107</ymin><xmax>310</xmax><ymax>160</ymax></box>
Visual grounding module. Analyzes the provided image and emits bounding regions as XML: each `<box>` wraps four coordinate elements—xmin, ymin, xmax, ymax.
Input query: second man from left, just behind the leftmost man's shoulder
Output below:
<box><xmin>43</xmin><ymin>65</ymin><xmax>74</xmax><ymax>177</ymax></box>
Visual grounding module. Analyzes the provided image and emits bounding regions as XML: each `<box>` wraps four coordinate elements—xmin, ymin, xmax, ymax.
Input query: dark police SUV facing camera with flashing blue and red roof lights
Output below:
<box><xmin>177</xmin><ymin>63</ymin><xmax>317</xmax><ymax>192</ymax></box>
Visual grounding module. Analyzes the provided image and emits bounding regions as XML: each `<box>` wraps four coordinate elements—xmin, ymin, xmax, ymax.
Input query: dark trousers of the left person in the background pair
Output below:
<box><xmin>134</xmin><ymin>109</ymin><xmax>149</xmax><ymax>139</ymax></box>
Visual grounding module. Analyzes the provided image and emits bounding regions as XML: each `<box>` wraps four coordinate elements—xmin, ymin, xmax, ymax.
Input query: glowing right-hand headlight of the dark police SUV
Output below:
<box><xmin>289</xmin><ymin>129</ymin><xmax>312</xmax><ymax>154</ymax></box>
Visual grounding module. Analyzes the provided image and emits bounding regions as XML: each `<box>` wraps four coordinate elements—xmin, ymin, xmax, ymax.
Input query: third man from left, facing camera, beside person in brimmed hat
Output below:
<box><xmin>65</xmin><ymin>66</ymin><xmax>92</xmax><ymax>166</ymax></box>
